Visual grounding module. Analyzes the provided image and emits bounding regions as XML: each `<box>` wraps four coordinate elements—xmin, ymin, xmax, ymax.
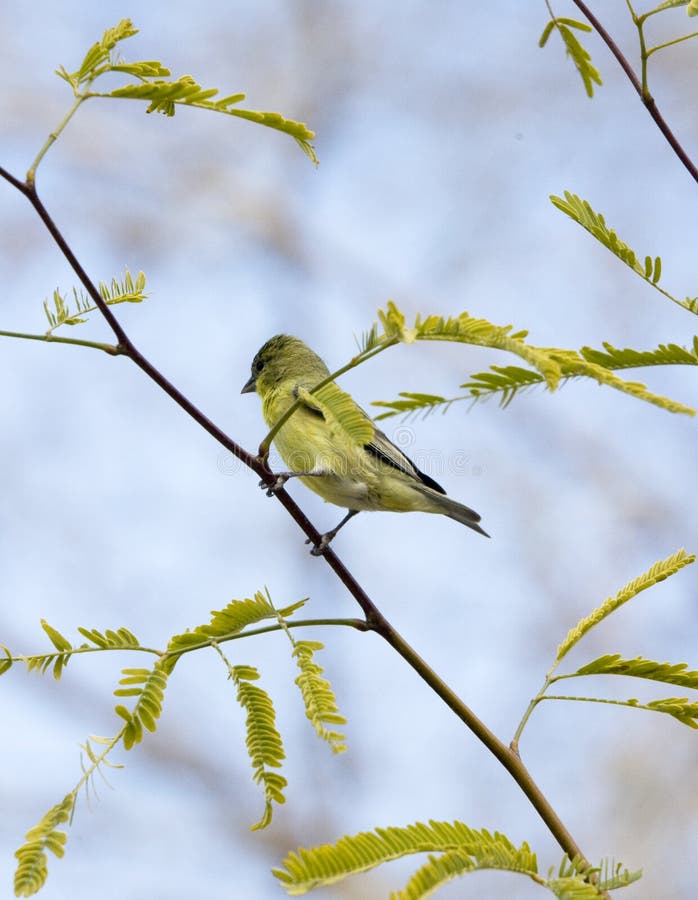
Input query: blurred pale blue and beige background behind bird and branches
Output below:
<box><xmin>0</xmin><ymin>0</ymin><xmax>698</xmax><ymax>900</ymax></box>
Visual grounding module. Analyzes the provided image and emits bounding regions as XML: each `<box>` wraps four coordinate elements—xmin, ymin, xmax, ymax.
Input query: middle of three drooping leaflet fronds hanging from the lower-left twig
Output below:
<box><xmin>229</xmin><ymin>666</ymin><xmax>288</xmax><ymax>831</ymax></box>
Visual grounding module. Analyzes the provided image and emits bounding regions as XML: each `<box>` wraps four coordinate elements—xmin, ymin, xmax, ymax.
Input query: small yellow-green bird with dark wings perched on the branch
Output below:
<box><xmin>241</xmin><ymin>334</ymin><xmax>489</xmax><ymax>555</ymax></box>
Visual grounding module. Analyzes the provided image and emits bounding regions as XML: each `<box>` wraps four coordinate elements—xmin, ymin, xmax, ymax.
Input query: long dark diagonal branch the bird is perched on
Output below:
<box><xmin>0</xmin><ymin>167</ymin><xmax>608</xmax><ymax>896</ymax></box>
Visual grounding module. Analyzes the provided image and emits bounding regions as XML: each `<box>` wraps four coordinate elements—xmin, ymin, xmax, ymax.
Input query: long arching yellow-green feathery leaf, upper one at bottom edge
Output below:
<box><xmin>274</xmin><ymin>820</ymin><xmax>537</xmax><ymax>896</ymax></box>
